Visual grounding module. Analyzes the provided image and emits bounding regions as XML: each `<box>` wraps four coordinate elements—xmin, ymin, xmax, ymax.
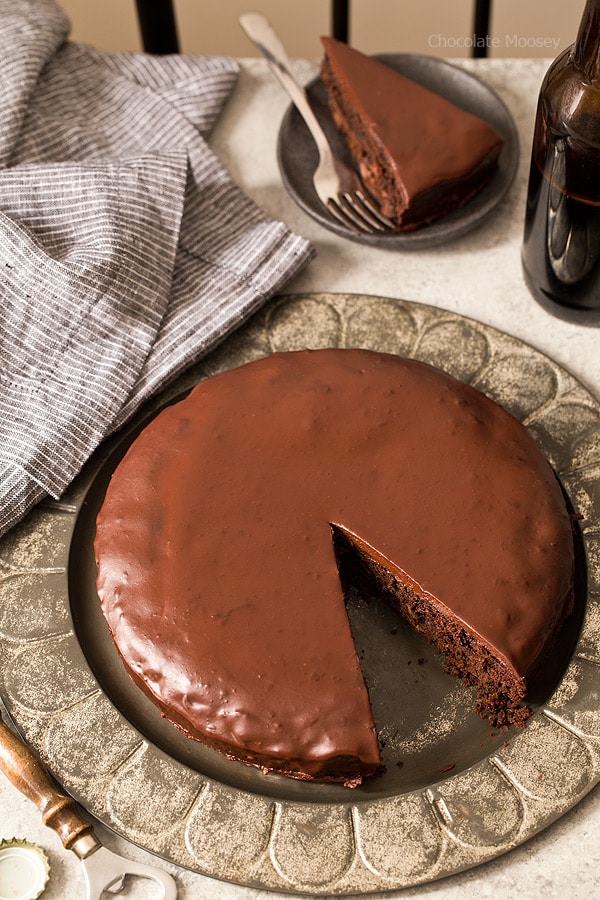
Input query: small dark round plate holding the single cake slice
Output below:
<box><xmin>277</xmin><ymin>53</ymin><xmax>519</xmax><ymax>250</ymax></box>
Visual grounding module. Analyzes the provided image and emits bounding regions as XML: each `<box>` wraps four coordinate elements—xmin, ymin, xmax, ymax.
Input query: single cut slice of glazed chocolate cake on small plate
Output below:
<box><xmin>321</xmin><ymin>37</ymin><xmax>502</xmax><ymax>232</ymax></box>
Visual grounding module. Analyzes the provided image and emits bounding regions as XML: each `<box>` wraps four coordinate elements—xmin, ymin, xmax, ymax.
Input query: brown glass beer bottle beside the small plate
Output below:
<box><xmin>522</xmin><ymin>0</ymin><xmax>600</xmax><ymax>325</ymax></box>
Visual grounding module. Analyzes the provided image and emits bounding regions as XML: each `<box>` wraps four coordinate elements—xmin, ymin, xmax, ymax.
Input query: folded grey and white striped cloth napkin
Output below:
<box><xmin>0</xmin><ymin>0</ymin><xmax>313</xmax><ymax>534</ymax></box>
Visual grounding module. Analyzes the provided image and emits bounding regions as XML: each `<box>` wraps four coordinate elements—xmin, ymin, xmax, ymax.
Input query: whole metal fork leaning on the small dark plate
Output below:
<box><xmin>240</xmin><ymin>13</ymin><xmax>394</xmax><ymax>234</ymax></box>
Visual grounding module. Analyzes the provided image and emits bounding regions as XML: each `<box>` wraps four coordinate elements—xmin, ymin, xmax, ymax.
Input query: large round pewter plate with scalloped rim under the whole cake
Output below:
<box><xmin>0</xmin><ymin>294</ymin><xmax>600</xmax><ymax>895</ymax></box>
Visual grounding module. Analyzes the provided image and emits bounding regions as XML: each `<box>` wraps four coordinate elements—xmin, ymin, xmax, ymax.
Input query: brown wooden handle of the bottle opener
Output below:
<box><xmin>0</xmin><ymin>719</ymin><xmax>93</xmax><ymax>852</ymax></box>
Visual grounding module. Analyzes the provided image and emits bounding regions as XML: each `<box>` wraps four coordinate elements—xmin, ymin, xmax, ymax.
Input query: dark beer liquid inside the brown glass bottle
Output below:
<box><xmin>522</xmin><ymin>136</ymin><xmax>600</xmax><ymax>311</ymax></box>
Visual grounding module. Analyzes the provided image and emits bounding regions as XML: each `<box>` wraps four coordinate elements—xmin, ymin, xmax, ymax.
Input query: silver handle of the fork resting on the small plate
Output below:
<box><xmin>240</xmin><ymin>13</ymin><xmax>329</xmax><ymax>161</ymax></box>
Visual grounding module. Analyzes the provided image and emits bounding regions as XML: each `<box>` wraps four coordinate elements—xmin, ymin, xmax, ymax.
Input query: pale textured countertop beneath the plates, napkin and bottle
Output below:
<box><xmin>0</xmin><ymin>60</ymin><xmax>600</xmax><ymax>900</ymax></box>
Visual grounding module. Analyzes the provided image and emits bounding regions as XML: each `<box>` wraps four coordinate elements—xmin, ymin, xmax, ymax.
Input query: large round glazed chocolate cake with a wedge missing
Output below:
<box><xmin>95</xmin><ymin>349</ymin><xmax>573</xmax><ymax>785</ymax></box>
